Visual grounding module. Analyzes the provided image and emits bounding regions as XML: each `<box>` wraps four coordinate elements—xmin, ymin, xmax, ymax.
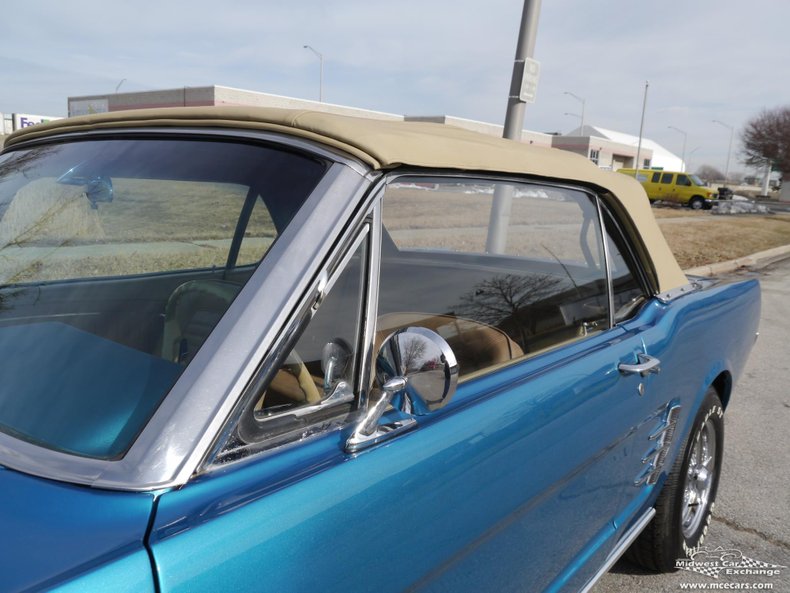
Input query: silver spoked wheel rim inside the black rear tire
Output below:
<box><xmin>681</xmin><ymin>418</ymin><xmax>716</xmax><ymax>539</ymax></box>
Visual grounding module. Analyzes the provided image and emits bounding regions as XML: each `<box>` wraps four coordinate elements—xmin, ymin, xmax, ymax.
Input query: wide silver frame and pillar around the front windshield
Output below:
<box><xmin>0</xmin><ymin>148</ymin><xmax>375</xmax><ymax>491</ymax></box>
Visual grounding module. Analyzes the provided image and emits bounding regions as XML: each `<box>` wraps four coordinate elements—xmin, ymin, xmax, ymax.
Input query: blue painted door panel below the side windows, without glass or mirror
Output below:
<box><xmin>152</xmin><ymin>329</ymin><xmax>656</xmax><ymax>592</ymax></box>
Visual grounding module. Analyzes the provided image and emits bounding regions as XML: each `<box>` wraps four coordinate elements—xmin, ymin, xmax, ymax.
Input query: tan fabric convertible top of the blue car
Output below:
<box><xmin>5</xmin><ymin>107</ymin><xmax>688</xmax><ymax>292</ymax></box>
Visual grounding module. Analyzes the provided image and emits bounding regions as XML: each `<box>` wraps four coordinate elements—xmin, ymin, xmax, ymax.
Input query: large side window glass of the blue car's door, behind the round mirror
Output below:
<box><xmin>376</xmin><ymin>178</ymin><xmax>609</xmax><ymax>378</ymax></box>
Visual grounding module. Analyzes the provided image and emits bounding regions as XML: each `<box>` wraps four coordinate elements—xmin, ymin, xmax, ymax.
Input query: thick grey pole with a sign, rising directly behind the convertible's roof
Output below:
<box><xmin>486</xmin><ymin>0</ymin><xmax>541</xmax><ymax>253</ymax></box>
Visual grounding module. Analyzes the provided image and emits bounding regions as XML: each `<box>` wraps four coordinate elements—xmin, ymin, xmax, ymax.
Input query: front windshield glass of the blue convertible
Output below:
<box><xmin>0</xmin><ymin>139</ymin><xmax>326</xmax><ymax>459</ymax></box>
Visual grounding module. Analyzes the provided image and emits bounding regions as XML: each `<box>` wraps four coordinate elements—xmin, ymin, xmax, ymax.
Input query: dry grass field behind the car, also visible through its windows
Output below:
<box><xmin>0</xmin><ymin>179</ymin><xmax>790</xmax><ymax>284</ymax></box>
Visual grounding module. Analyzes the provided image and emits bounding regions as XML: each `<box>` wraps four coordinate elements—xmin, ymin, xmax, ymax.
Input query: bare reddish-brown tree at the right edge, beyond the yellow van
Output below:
<box><xmin>741</xmin><ymin>106</ymin><xmax>790</xmax><ymax>174</ymax></box>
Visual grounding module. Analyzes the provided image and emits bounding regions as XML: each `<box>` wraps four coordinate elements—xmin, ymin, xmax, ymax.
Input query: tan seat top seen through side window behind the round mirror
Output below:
<box><xmin>374</xmin><ymin>313</ymin><xmax>524</xmax><ymax>376</ymax></box>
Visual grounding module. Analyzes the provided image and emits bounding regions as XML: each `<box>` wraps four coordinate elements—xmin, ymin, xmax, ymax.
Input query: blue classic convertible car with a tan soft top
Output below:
<box><xmin>0</xmin><ymin>108</ymin><xmax>760</xmax><ymax>593</ymax></box>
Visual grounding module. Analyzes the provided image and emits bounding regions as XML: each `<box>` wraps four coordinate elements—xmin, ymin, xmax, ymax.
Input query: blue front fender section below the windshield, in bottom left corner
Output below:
<box><xmin>0</xmin><ymin>468</ymin><xmax>154</xmax><ymax>593</ymax></box>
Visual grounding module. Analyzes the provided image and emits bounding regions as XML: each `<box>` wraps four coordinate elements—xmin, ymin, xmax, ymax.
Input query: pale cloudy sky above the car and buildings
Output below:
<box><xmin>0</xmin><ymin>0</ymin><xmax>790</xmax><ymax>172</ymax></box>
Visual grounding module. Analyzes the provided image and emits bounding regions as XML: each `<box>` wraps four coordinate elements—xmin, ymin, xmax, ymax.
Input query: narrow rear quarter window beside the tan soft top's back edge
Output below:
<box><xmin>604</xmin><ymin>209</ymin><xmax>647</xmax><ymax>323</ymax></box>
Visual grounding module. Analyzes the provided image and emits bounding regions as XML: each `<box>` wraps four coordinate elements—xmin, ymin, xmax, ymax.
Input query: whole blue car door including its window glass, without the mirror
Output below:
<box><xmin>149</xmin><ymin>177</ymin><xmax>664</xmax><ymax>592</ymax></box>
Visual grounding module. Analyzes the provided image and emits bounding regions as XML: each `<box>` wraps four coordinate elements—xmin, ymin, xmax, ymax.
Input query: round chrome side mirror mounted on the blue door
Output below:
<box><xmin>346</xmin><ymin>327</ymin><xmax>458</xmax><ymax>452</ymax></box>
